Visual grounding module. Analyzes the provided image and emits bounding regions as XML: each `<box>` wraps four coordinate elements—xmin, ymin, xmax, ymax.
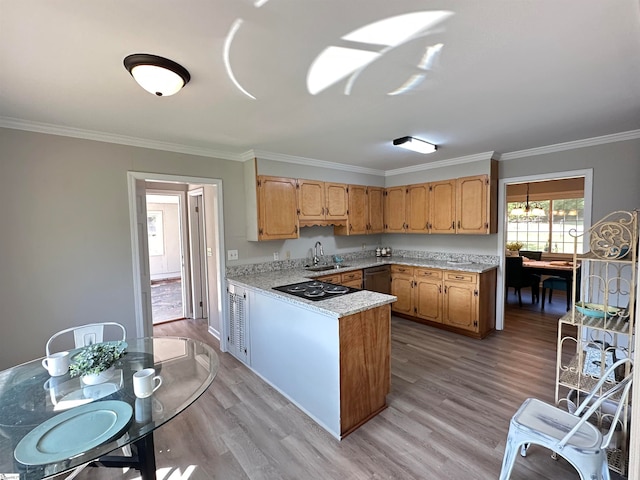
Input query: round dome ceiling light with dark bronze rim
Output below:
<box><xmin>124</xmin><ymin>53</ymin><xmax>191</xmax><ymax>97</ymax></box>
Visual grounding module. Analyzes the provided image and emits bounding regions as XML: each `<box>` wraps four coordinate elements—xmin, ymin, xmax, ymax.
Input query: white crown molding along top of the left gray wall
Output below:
<box><xmin>0</xmin><ymin>117</ymin><xmax>243</xmax><ymax>162</ymax></box>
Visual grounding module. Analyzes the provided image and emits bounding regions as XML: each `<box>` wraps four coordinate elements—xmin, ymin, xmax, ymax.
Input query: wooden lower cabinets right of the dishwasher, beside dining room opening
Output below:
<box><xmin>391</xmin><ymin>265</ymin><xmax>496</xmax><ymax>338</ymax></box>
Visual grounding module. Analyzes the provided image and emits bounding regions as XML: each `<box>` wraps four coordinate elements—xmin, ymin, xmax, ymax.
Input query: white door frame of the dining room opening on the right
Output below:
<box><xmin>496</xmin><ymin>168</ymin><xmax>593</xmax><ymax>330</ymax></box>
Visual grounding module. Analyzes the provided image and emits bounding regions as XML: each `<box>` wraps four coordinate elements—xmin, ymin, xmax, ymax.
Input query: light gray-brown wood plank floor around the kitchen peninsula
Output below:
<box><xmin>77</xmin><ymin>296</ymin><xmax>592</xmax><ymax>480</ymax></box>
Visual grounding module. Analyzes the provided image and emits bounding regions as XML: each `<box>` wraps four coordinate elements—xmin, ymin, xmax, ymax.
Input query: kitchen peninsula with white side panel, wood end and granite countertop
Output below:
<box><xmin>227</xmin><ymin>257</ymin><xmax>496</xmax><ymax>439</ymax></box>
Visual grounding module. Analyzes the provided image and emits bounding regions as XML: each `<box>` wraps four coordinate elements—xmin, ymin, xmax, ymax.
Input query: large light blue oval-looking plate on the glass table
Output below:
<box><xmin>13</xmin><ymin>400</ymin><xmax>133</xmax><ymax>465</ymax></box>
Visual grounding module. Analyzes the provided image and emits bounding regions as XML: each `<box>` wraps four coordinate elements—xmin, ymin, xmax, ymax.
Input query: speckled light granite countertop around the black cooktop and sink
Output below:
<box><xmin>227</xmin><ymin>257</ymin><xmax>497</xmax><ymax>318</ymax></box>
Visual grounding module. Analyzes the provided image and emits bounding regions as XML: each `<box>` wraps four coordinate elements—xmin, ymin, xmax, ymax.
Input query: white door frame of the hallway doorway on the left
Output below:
<box><xmin>127</xmin><ymin>171</ymin><xmax>227</xmax><ymax>344</ymax></box>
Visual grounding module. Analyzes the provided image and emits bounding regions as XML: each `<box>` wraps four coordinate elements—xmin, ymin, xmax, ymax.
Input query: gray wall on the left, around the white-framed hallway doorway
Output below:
<box><xmin>0</xmin><ymin>129</ymin><xmax>240</xmax><ymax>369</ymax></box>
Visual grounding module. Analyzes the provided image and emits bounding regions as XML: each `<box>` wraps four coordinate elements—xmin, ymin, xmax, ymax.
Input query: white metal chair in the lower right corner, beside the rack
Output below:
<box><xmin>500</xmin><ymin>358</ymin><xmax>633</xmax><ymax>480</ymax></box>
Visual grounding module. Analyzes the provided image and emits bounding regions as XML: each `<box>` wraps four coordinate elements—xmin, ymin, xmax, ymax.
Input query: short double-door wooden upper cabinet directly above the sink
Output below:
<box><xmin>297</xmin><ymin>180</ymin><xmax>348</xmax><ymax>226</ymax></box>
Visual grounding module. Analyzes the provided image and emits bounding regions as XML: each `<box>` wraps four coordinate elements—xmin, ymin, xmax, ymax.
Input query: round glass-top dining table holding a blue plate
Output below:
<box><xmin>0</xmin><ymin>337</ymin><xmax>219</xmax><ymax>480</ymax></box>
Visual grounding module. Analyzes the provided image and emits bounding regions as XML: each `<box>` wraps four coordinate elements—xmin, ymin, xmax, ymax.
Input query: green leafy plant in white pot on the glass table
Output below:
<box><xmin>69</xmin><ymin>341</ymin><xmax>127</xmax><ymax>385</ymax></box>
